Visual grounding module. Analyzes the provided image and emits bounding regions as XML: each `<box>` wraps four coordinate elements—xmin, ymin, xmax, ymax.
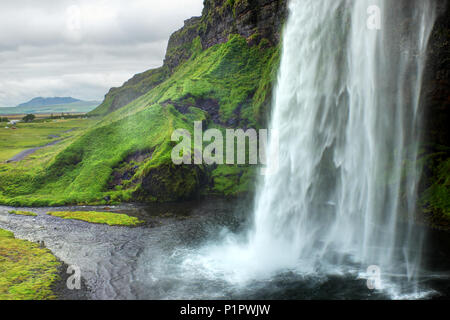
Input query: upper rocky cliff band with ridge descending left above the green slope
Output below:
<box><xmin>90</xmin><ymin>0</ymin><xmax>287</xmax><ymax>115</ymax></box>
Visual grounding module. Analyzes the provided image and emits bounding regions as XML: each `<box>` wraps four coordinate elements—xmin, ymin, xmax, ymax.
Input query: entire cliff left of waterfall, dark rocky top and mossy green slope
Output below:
<box><xmin>0</xmin><ymin>0</ymin><xmax>286</xmax><ymax>206</ymax></box>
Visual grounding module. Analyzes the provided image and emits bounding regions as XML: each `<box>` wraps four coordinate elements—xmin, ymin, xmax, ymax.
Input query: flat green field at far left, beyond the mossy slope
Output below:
<box><xmin>0</xmin><ymin>119</ymin><xmax>94</xmax><ymax>162</ymax></box>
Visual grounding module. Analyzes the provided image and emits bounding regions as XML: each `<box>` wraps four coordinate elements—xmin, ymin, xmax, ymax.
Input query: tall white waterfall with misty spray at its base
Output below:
<box><xmin>192</xmin><ymin>0</ymin><xmax>436</xmax><ymax>298</ymax></box>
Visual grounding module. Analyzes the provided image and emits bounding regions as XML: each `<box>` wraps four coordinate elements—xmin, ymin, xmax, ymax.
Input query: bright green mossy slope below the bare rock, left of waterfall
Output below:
<box><xmin>0</xmin><ymin>35</ymin><xmax>279</xmax><ymax>206</ymax></box>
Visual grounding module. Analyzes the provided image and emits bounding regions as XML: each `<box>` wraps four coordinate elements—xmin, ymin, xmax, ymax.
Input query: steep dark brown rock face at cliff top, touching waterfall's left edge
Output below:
<box><xmin>164</xmin><ymin>0</ymin><xmax>287</xmax><ymax>70</ymax></box>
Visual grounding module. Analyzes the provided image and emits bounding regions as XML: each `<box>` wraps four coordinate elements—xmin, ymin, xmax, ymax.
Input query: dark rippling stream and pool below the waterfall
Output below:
<box><xmin>0</xmin><ymin>199</ymin><xmax>450</xmax><ymax>299</ymax></box>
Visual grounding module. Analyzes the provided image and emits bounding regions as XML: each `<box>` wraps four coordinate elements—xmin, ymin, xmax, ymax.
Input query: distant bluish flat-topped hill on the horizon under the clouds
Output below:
<box><xmin>0</xmin><ymin>97</ymin><xmax>100</xmax><ymax>115</ymax></box>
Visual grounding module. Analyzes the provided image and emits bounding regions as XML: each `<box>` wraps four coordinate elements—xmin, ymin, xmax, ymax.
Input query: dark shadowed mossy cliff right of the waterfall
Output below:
<box><xmin>420</xmin><ymin>1</ymin><xmax>450</xmax><ymax>229</ymax></box>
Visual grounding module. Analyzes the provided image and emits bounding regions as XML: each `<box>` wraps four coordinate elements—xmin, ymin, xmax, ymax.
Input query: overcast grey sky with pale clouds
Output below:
<box><xmin>0</xmin><ymin>0</ymin><xmax>203</xmax><ymax>107</ymax></box>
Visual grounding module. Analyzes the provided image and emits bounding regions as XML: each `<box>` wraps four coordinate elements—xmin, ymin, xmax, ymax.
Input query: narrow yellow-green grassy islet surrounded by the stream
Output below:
<box><xmin>47</xmin><ymin>211</ymin><xmax>143</xmax><ymax>226</ymax></box>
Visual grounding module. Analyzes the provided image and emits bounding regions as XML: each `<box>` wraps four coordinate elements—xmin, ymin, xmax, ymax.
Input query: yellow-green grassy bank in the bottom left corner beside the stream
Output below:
<box><xmin>0</xmin><ymin>229</ymin><xmax>61</xmax><ymax>300</ymax></box>
